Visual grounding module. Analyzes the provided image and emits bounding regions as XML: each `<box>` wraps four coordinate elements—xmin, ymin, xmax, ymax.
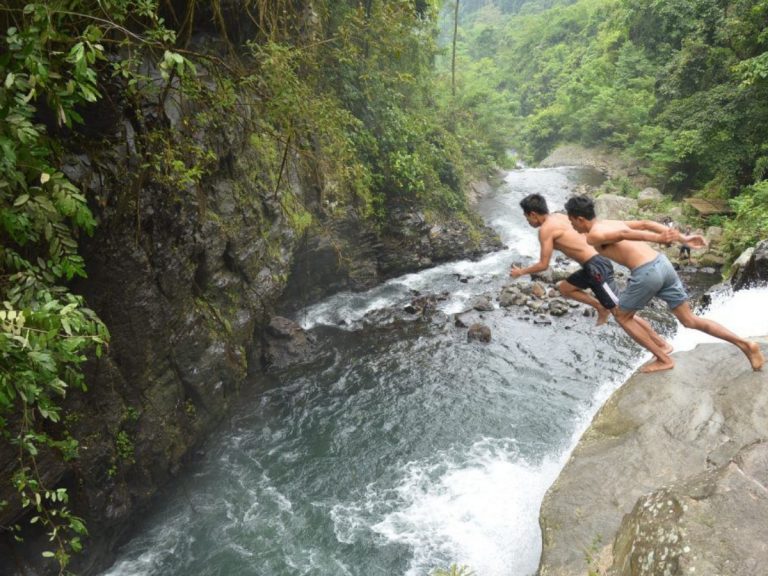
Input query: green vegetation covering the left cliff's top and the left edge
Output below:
<box><xmin>0</xmin><ymin>0</ymin><xmax>500</xmax><ymax>571</ymax></box>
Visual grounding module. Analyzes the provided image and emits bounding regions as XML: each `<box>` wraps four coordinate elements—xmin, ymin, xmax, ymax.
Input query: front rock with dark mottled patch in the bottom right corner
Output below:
<box><xmin>609</xmin><ymin>441</ymin><xmax>768</xmax><ymax>576</ymax></box>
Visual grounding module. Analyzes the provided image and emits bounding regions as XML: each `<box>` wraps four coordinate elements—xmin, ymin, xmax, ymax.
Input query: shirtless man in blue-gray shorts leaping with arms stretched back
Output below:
<box><xmin>565</xmin><ymin>196</ymin><xmax>765</xmax><ymax>372</ymax></box>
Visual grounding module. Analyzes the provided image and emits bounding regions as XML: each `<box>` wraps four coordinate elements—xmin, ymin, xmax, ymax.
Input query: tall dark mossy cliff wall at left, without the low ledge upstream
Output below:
<box><xmin>0</xmin><ymin>99</ymin><xmax>298</xmax><ymax>574</ymax></box>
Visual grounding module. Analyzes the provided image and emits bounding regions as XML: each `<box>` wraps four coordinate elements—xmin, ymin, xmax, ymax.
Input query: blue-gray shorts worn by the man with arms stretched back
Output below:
<box><xmin>619</xmin><ymin>254</ymin><xmax>688</xmax><ymax>311</ymax></box>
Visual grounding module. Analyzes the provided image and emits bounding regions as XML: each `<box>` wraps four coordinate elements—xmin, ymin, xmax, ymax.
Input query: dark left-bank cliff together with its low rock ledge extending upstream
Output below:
<box><xmin>0</xmin><ymin>104</ymin><xmax>500</xmax><ymax>575</ymax></box>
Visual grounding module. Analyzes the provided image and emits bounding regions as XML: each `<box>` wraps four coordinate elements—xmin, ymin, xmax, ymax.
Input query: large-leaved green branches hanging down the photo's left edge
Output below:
<box><xmin>0</xmin><ymin>2</ymin><xmax>119</xmax><ymax>570</ymax></box>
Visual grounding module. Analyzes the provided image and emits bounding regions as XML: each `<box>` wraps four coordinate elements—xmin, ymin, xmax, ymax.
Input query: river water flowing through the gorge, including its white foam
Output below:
<box><xmin>104</xmin><ymin>168</ymin><xmax>768</xmax><ymax>576</ymax></box>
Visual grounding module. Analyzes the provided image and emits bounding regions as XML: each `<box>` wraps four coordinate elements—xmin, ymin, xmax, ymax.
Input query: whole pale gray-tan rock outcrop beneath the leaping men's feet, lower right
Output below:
<box><xmin>539</xmin><ymin>338</ymin><xmax>768</xmax><ymax>576</ymax></box>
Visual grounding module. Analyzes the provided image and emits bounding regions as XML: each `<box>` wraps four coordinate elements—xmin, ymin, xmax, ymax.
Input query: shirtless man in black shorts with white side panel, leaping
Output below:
<box><xmin>509</xmin><ymin>194</ymin><xmax>672</xmax><ymax>354</ymax></box>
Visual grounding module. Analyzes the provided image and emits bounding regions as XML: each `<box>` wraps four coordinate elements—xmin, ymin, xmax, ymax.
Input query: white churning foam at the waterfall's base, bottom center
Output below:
<box><xmin>331</xmin><ymin>439</ymin><xmax>561</xmax><ymax>576</ymax></box>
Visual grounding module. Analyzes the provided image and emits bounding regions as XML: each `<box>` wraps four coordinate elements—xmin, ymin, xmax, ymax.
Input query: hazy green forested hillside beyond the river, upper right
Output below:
<box><xmin>444</xmin><ymin>0</ymin><xmax>768</xmax><ymax>252</ymax></box>
